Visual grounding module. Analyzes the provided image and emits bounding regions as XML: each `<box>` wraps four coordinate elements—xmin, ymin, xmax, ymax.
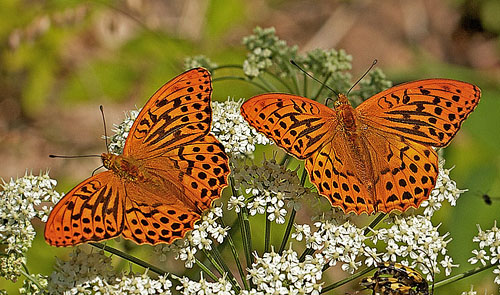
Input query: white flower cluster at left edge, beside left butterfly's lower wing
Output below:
<box><xmin>0</xmin><ymin>173</ymin><xmax>62</xmax><ymax>281</ymax></box>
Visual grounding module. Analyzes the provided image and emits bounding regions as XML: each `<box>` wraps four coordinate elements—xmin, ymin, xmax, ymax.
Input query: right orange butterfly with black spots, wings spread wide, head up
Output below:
<box><xmin>241</xmin><ymin>79</ymin><xmax>481</xmax><ymax>214</ymax></box>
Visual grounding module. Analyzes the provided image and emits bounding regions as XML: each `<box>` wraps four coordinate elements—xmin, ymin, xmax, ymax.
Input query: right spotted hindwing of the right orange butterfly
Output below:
<box><xmin>361</xmin><ymin>127</ymin><xmax>438</xmax><ymax>213</ymax></box>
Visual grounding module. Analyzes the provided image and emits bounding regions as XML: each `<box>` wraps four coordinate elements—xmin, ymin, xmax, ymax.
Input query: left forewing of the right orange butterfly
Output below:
<box><xmin>241</xmin><ymin>93</ymin><xmax>338</xmax><ymax>159</ymax></box>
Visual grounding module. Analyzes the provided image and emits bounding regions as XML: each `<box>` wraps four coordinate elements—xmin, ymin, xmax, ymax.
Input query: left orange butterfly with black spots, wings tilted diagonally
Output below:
<box><xmin>45</xmin><ymin>68</ymin><xmax>229</xmax><ymax>246</ymax></box>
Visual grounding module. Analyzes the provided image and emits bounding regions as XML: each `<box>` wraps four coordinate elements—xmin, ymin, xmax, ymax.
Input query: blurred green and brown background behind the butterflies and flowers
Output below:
<box><xmin>0</xmin><ymin>0</ymin><xmax>500</xmax><ymax>294</ymax></box>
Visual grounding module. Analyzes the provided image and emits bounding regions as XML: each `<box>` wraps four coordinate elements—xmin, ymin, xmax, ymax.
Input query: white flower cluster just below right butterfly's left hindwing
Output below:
<box><xmin>292</xmin><ymin>219</ymin><xmax>366</xmax><ymax>273</ymax></box>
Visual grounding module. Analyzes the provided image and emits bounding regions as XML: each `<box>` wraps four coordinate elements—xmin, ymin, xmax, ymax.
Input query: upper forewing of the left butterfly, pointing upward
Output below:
<box><xmin>123</xmin><ymin>68</ymin><xmax>212</xmax><ymax>159</ymax></box>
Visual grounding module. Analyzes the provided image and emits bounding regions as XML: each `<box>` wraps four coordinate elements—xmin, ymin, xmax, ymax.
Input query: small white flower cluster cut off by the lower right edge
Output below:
<box><xmin>468</xmin><ymin>220</ymin><xmax>500</xmax><ymax>285</ymax></box>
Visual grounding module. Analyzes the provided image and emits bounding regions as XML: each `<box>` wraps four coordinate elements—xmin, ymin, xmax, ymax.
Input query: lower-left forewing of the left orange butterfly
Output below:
<box><xmin>45</xmin><ymin>171</ymin><xmax>125</xmax><ymax>247</ymax></box>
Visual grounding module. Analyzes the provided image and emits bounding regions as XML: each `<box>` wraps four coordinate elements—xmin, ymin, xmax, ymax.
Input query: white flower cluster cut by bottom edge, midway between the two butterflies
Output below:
<box><xmin>247</xmin><ymin>248</ymin><xmax>324</xmax><ymax>295</ymax></box>
